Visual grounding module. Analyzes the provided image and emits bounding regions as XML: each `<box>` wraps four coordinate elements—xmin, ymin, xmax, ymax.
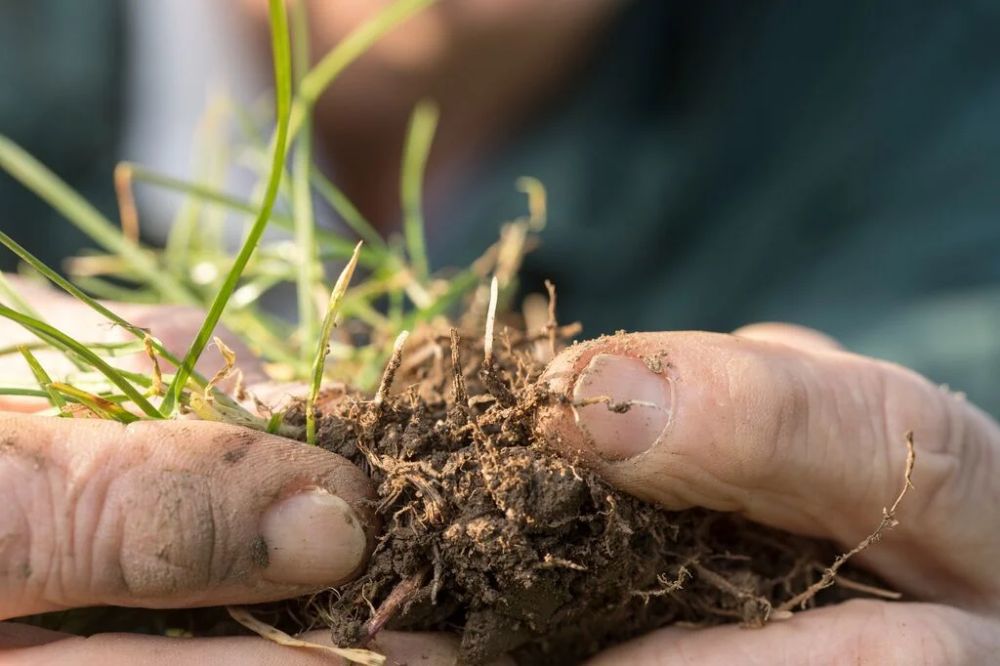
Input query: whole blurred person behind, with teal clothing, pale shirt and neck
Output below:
<box><xmin>0</xmin><ymin>0</ymin><xmax>1000</xmax><ymax>414</ymax></box>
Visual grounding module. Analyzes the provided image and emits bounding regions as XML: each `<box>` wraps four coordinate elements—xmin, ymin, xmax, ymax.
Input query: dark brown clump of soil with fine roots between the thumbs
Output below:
<box><xmin>282</xmin><ymin>325</ymin><xmax>892</xmax><ymax>664</ymax></box>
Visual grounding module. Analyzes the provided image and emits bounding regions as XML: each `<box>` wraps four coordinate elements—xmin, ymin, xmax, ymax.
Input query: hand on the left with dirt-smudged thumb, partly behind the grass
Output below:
<box><xmin>0</xmin><ymin>285</ymin><xmax>492</xmax><ymax>666</ymax></box>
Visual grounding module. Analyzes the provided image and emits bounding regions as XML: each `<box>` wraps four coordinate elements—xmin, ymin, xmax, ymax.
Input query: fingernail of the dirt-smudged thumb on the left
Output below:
<box><xmin>260</xmin><ymin>488</ymin><xmax>367</xmax><ymax>585</ymax></box>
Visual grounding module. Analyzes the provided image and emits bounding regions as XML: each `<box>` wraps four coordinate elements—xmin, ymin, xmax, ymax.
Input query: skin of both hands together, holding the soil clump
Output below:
<box><xmin>0</xmin><ymin>282</ymin><xmax>1000</xmax><ymax>666</ymax></box>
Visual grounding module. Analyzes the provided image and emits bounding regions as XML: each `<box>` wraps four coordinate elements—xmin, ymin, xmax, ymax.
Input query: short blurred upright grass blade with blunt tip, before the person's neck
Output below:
<box><xmin>399</xmin><ymin>100</ymin><xmax>439</xmax><ymax>281</ymax></box>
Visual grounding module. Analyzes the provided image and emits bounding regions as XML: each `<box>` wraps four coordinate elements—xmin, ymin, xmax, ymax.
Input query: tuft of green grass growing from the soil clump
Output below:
<box><xmin>0</xmin><ymin>0</ymin><xmax>544</xmax><ymax>430</ymax></box>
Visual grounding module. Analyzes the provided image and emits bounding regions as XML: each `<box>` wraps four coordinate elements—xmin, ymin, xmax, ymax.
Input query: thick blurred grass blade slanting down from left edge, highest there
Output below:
<box><xmin>0</xmin><ymin>135</ymin><xmax>194</xmax><ymax>303</ymax></box>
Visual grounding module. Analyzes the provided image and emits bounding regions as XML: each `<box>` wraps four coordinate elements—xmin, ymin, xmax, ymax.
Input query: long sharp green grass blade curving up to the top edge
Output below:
<box><xmin>163</xmin><ymin>0</ymin><xmax>292</xmax><ymax>413</ymax></box>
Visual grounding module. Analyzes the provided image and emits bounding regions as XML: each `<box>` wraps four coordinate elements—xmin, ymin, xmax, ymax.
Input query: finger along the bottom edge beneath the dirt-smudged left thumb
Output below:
<box><xmin>0</xmin><ymin>624</ymin><xmax>512</xmax><ymax>666</ymax></box>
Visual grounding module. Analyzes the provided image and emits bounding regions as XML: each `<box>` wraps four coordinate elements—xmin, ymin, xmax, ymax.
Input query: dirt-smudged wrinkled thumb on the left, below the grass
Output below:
<box><xmin>0</xmin><ymin>415</ymin><xmax>369</xmax><ymax>618</ymax></box>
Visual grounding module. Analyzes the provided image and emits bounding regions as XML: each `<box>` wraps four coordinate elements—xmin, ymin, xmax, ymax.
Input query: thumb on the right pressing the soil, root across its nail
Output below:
<box><xmin>541</xmin><ymin>333</ymin><xmax>1000</xmax><ymax>603</ymax></box>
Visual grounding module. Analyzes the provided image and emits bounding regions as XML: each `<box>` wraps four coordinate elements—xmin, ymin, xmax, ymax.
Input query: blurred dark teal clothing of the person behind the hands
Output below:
<box><xmin>0</xmin><ymin>0</ymin><xmax>1000</xmax><ymax>414</ymax></box>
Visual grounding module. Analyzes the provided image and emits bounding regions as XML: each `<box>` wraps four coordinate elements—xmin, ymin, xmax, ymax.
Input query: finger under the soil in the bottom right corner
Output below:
<box><xmin>588</xmin><ymin>601</ymin><xmax>1000</xmax><ymax>666</ymax></box>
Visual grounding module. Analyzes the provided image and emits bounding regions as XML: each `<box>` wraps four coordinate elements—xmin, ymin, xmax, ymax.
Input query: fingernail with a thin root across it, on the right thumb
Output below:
<box><xmin>573</xmin><ymin>354</ymin><xmax>672</xmax><ymax>460</ymax></box>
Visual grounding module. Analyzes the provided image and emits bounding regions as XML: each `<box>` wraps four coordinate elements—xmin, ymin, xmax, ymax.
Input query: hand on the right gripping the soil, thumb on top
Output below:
<box><xmin>543</xmin><ymin>324</ymin><xmax>1000</xmax><ymax>664</ymax></box>
